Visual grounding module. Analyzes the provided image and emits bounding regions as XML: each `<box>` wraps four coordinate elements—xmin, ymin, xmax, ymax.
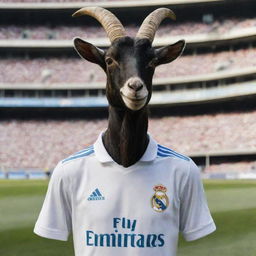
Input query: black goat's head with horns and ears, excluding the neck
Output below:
<box><xmin>72</xmin><ymin>7</ymin><xmax>185</xmax><ymax>111</ymax></box>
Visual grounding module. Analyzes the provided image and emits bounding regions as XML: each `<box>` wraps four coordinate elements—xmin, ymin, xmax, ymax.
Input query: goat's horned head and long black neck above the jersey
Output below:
<box><xmin>73</xmin><ymin>7</ymin><xmax>185</xmax><ymax>167</ymax></box>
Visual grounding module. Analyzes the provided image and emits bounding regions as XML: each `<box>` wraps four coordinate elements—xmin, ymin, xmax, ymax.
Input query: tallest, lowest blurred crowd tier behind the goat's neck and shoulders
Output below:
<box><xmin>0</xmin><ymin>111</ymin><xmax>256</xmax><ymax>171</ymax></box>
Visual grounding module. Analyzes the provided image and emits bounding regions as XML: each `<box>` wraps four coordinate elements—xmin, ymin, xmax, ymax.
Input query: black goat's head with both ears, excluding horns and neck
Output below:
<box><xmin>74</xmin><ymin>37</ymin><xmax>185</xmax><ymax>111</ymax></box>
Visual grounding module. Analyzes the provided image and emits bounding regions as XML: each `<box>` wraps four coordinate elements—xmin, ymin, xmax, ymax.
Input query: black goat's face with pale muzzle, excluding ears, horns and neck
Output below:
<box><xmin>105</xmin><ymin>37</ymin><xmax>154</xmax><ymax>111</ymax></box>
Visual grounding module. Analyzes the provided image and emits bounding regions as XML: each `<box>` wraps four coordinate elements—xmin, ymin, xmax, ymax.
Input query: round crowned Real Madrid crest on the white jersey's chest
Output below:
<box><xmin>151</xmin><ymin>185</ymin><xmax>169</xmax><ymax>212</ymax></box>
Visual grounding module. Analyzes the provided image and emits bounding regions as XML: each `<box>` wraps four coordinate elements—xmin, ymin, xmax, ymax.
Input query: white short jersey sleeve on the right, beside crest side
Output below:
<box><xmin>180</xmin><ymin>160</ymin><xmax>216</xmax><ymax>241</ymax></box>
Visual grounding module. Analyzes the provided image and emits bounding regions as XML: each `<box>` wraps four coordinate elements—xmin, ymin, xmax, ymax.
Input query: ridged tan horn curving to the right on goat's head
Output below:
<box><xmin>136</xmin><ymin>8</ymin><xmax>176</xmax><ymax>43</ymax></box>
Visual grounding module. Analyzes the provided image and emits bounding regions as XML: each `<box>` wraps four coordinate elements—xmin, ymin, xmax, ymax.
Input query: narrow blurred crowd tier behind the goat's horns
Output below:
<box><xmin>0</xmin><ymin>17</ymin><xmax>256</xmax><ymax>40</ymax></box>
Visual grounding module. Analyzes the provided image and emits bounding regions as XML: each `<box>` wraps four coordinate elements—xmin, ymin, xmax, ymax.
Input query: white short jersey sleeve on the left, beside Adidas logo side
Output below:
<box><xmin>34</xmin><ymin>163</ymin><xmax>72</xmax><ymax>241</ymax></box>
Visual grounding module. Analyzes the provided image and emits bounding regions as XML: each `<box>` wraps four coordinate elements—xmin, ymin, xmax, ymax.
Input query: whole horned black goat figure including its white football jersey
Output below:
<box><xmin>34</xmin><ymin>7</ymin><xmax>216</xmax><ymax>253</ymax></box>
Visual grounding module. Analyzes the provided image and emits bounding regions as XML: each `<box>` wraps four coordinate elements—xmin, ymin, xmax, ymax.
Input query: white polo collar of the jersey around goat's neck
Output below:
<box><xmin>93</xmin><ymin>132</ymin><xmax>157</xmax><ymax>163</ymax></box>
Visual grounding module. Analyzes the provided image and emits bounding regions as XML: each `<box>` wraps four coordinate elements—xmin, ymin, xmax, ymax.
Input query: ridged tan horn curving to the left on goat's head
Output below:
<box><xmin>72</xmin><ymin>7</ymin><xmax>126</xmax><ymax>43</ymax></box>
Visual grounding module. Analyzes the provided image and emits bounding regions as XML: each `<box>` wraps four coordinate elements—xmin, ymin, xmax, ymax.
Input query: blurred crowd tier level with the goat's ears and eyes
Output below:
<box><xmin>0</xmin><ymin>48</ymin><xmax>256</xmax><ymax>83</ymax></box>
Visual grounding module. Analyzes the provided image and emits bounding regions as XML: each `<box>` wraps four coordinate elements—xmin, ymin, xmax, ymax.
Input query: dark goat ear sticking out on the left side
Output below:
<box><xmin>73</xmin><ymin>38</ymin><xmax>106</xmax><ymax>70</ymax></box>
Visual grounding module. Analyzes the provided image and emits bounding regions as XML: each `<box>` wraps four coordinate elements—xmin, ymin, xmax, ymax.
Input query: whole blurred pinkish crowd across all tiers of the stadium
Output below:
<box><xmin>0</xmin><ymin>9</ymin><xmax>256</xmax><ymax>175</ymax></box>
